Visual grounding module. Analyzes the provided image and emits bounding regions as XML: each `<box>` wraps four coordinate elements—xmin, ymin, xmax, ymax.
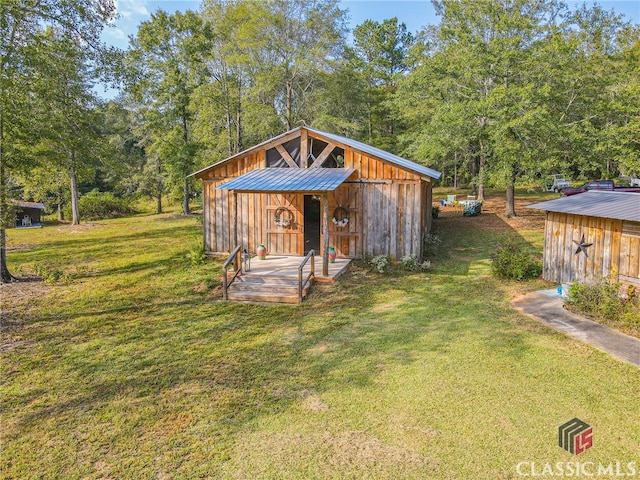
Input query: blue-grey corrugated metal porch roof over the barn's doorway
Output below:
<box><xmin>216</xmin><ymin>168</ymin><xmax>355</xmax><ymax>192</ymax></box>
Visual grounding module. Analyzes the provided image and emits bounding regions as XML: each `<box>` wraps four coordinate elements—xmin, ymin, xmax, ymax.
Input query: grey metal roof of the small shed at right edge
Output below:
<box><xmin>527</xmin><ymin>190</ymin><xmax>640</xmax><ymax>222</ymax></box>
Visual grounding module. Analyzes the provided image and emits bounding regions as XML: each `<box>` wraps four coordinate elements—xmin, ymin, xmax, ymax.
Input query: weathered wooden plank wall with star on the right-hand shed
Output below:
<box><xmin>543</xmin><ymin>212</ymin><xmax>640</xmax><ymax>284</ymax></box>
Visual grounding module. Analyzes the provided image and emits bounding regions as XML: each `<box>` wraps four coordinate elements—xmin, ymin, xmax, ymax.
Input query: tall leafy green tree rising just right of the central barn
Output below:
<box><xmin>403</xmin><ymin>0</ymin><xmax>563</xmax><ymax>216</ymax></box>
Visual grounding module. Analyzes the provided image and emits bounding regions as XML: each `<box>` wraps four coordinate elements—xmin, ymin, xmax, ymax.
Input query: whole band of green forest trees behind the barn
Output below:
<box><xmin>0</xmin><ymin>0</ymin><xmax>640</xmax><ymax>281</ymax></box>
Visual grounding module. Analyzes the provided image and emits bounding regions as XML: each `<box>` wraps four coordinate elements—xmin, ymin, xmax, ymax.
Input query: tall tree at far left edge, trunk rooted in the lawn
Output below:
<box><xmin>0</xmin><ymin>0</ymin><xmax>115</xmax><ymax>282</ymax></box>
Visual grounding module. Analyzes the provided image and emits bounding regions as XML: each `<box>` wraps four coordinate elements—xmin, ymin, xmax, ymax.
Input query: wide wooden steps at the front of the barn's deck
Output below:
<box><xmin>227</xmin><ymin>275</ymin><xmax>309</xmax><ymax>303</ymax></box>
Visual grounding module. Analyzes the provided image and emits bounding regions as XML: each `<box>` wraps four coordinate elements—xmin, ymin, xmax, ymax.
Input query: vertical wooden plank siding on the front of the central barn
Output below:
<box><xmin>201</xmin><ymin>133</ymin><xmax>432</xmax><ymax>259</ymax></box>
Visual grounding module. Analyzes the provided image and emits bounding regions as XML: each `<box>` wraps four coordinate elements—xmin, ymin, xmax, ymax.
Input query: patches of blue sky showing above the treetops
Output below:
<box><xmin>104</xmin><ymin>0</ymin><xmax>640</xmax><ymax>49</ymax></box>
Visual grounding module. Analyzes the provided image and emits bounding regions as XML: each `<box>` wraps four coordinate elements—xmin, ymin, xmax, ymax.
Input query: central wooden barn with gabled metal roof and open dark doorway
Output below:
<box><xmin>192</xmin><ymin>127</ymin><xmax>440</xmax><ymax>272</ymax></box>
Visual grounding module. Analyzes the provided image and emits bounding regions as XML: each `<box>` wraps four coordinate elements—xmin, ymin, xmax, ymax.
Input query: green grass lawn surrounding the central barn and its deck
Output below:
<box><xmin>0</xmin><ymin>192</ymin><xmax>640</xmax><ymax>479</ymax></box>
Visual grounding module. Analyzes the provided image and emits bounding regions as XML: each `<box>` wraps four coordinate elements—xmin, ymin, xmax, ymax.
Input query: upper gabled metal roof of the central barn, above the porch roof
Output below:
<box><xmin>189</xmin><ymin>127</ymin><xmax>442</xmax><ymax>179</ymax></box>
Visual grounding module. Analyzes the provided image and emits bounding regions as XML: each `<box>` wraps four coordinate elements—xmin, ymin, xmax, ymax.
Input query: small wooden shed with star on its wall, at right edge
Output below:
<box><xmin>528</xmin><ymin>190</ymin><xmax>640</xmax><ymax>286</ymax></box>
